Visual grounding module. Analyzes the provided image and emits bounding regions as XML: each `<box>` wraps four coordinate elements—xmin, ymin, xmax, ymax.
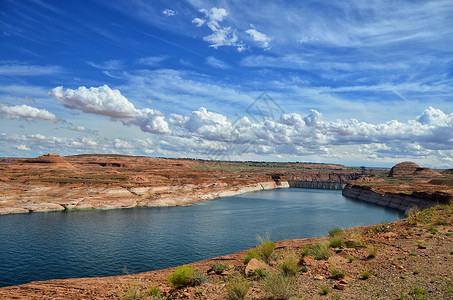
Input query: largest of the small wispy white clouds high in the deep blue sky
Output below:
<box><xmin>192</xmin><ymin>7</ymin><xmax>245</xmax><ymax>52</ymax></box>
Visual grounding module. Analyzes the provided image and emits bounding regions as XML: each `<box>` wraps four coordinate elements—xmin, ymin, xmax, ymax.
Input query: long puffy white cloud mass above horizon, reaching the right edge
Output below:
<box><xmin>170</xmin><ymin>107</ymin><xmax>453</xmax><ymax>164</ymax></box>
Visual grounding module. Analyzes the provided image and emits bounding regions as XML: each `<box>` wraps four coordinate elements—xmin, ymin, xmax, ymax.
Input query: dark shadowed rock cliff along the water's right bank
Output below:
<box><xmin>342</xmin><ymin>184</ymin><xmax>453</xmax><ymax>212</ymax></box>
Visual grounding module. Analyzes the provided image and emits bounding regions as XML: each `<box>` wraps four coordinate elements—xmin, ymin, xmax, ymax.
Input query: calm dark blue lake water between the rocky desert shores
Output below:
<box><xmin>0</xmin><ymin>189</ymin><xmax>402</xmax><ymax>286</ymax></box>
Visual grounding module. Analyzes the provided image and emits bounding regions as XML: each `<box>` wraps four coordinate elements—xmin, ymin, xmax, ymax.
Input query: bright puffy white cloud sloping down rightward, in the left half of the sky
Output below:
<box><xmin>49</xmin><ymin>85</ymin><xmax>171</xmax><ymax>134</ymax></box>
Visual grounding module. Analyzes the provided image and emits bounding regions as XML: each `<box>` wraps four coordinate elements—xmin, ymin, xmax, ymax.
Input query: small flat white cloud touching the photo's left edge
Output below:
<box><xmin>0</xmin><ymin>104</ymin><xmax>59</xmax><ymax>122</ymax></box>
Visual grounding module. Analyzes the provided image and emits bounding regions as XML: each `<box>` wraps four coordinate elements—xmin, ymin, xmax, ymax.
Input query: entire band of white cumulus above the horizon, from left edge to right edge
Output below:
<box><xmin>0</xmin><ymin>85</ymin><xmax>453</xmax><ymax>169</ymax></box>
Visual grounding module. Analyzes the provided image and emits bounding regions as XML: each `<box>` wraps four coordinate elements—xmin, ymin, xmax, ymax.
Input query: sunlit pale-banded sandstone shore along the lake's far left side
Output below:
<box><xmin>0</xmin><ymin>181</ymin><xmax>288</xmax><ymax>215</ymax></box>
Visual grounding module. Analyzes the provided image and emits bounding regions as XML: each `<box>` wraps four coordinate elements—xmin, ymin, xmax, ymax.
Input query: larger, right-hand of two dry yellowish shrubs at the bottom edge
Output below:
<box><xmin>259</xmin><ymin>272</ymin><xmax>294</xmax><ymax>299</ymax></box>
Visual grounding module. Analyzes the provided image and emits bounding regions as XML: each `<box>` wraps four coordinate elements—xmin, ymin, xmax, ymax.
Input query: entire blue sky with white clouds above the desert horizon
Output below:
<box><xmin>0</xmin><ymin>0</ymin><xmax>453</xmax><ymax>168</ymax></box>
